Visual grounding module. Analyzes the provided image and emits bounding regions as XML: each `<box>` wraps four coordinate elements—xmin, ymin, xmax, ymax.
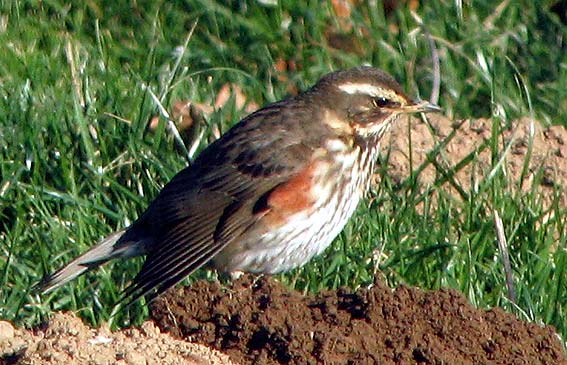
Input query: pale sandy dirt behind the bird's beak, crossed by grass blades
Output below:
<box><xmin>383</xmin><ymin>115</ymin><xmax>567</xmax><ymax>206</ymax></box>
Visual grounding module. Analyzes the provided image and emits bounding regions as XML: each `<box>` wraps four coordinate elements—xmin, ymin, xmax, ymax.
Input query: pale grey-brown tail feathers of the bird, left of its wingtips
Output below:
<box><xmin>34</xmin><ymin>230</ymin><xmax>138</xmax><ymax>293</ymax></box>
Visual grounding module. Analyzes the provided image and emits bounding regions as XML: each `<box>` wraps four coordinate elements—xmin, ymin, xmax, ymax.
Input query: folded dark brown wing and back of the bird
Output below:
<box><xmin>122</xmin><ymin>104</ymin><xmax>322</xmax><ymax>303</ymax></box>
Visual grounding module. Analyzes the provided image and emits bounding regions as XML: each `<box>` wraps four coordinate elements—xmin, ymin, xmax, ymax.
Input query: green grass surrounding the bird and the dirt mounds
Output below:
<box><xmin>0</xmin><ymin>0</ymin><xmax>567</xmax><ymax>338</ymax></box>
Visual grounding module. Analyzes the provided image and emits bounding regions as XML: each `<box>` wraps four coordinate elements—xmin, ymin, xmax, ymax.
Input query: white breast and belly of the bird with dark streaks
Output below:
<box><xmin>213</xmin><ymin>139</ymin><xmax>374</xmax><ymax>274</ymax></box>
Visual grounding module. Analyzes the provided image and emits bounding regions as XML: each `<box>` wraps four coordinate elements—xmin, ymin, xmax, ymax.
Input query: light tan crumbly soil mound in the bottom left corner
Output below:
<box><xmin>0</xmin><ymin>313</ymin><xmax>235</xmax><ymax>365</ymax></box>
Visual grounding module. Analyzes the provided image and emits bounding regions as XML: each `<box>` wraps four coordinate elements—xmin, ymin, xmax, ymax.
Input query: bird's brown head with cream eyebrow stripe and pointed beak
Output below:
<box><xmin>311</xmin><ymin>67</ymin><xmax>441</xmax><ymax>139</ymax></box>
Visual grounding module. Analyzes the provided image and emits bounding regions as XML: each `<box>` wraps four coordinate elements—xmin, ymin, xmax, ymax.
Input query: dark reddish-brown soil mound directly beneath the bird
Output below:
<box><xmin>152</xmin><ymin>275</ymin><xmax>567</xmax><ymax>365</ymax></box>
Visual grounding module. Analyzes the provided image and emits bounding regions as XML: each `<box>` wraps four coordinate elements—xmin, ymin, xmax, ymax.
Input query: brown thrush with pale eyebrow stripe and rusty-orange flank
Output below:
<box><xmin>36</xmin><ymin>66</ymin><xmax>441</xmax><ymax>303</ymax></box>
